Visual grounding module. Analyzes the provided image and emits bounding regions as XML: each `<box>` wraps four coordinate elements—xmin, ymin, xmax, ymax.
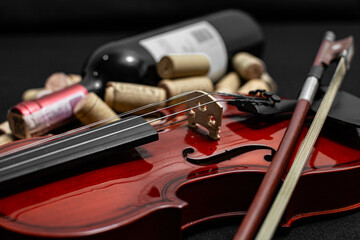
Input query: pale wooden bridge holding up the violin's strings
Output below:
<box><xmin>186</xmin><ymin>91</ymin><xmax>223</xmax><ymax>140</ymax></box>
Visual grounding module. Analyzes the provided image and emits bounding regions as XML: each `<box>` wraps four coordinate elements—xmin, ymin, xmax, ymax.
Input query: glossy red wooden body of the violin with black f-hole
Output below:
<box><xmin>0</xmin><ymin>102</ymin><xmax>360</xmax><ymax>239</ymax></box>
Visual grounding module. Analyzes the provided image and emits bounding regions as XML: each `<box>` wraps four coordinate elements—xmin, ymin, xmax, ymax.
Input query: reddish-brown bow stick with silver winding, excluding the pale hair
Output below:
<box><xmin>234</xmin><ymin>31</ymin><xmax>353</xmax><ymax>240</ymax></box>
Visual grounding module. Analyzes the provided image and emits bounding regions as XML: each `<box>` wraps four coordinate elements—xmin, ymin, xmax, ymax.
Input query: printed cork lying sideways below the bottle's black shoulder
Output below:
<box><xmin>105</xmin><ymin>82</ymin><xmax>166</xmax><ymax>114</ymax></box>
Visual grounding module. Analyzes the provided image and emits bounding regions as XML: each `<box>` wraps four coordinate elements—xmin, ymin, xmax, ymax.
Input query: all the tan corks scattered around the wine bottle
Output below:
<box><xmin>0</xmin><ymin>52</ymin><xmax>276</xmax><ymax>145</ymax></box>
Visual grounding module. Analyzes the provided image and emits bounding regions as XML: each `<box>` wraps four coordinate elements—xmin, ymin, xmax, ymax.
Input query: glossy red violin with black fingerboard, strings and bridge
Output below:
<box><xmin>0</xmin><ymin>31</ymin><xmax>360</xmax><ymax>239</ymax></box>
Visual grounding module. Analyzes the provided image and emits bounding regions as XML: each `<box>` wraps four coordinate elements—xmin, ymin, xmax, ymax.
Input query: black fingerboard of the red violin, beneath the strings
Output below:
<box><xmin>0</xmin><ymin>116</ymin><xmax>158</xmax><ymax>191</ymax></box>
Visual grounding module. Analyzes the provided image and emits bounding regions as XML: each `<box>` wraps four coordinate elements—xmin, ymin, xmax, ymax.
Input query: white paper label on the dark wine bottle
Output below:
<box><xmin>139</xmin><ymin>21</ymin><xmax>228</xmax><ymax>81</ymax></box>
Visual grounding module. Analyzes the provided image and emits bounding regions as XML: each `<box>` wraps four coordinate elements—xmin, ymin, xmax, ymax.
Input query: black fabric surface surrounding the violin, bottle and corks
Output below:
<box><xmin>0</xmin><ymin>0</ymin><xmax>360</xmax><ymax>240</ymax></box>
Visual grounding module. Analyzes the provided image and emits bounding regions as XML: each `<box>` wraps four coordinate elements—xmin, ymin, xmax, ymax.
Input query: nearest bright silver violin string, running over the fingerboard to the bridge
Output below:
<box><xmin>0</xmin><ymin>96</ymin><xmax>227</xmax><ymax>172</ymax></box>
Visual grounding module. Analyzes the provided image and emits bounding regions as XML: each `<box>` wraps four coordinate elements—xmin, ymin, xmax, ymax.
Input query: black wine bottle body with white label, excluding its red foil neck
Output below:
<box><xmin>82</xmin><ymin>10</ymin><xmax>263</xmax><ymax>95</ymax></box>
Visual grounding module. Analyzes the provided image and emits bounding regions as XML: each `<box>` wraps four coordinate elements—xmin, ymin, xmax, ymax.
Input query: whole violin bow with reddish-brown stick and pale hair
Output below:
<box><xmin>234</xmin><ymin>31</ymin><xmax>353</xmax><ymax>240</ymax></box>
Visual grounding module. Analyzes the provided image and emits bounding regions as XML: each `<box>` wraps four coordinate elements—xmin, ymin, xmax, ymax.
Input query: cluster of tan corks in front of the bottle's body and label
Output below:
<box><xmin>105</xmin><ymin>52</ymin><xmax>276</xmax><ymax>114</ymax></box>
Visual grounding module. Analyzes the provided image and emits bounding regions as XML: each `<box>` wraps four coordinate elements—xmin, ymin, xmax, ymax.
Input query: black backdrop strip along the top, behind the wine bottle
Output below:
<box><xmin>0</xmin><ymin>0</ymin><xmax>360</xmax><ymax>31</ymax></box>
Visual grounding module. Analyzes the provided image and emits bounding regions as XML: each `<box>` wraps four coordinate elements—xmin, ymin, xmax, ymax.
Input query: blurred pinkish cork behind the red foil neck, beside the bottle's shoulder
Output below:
<box><xmin>45</xmin><ymin>72</ymin><xmax>81</xmax><ymax>92</ymax></box>
